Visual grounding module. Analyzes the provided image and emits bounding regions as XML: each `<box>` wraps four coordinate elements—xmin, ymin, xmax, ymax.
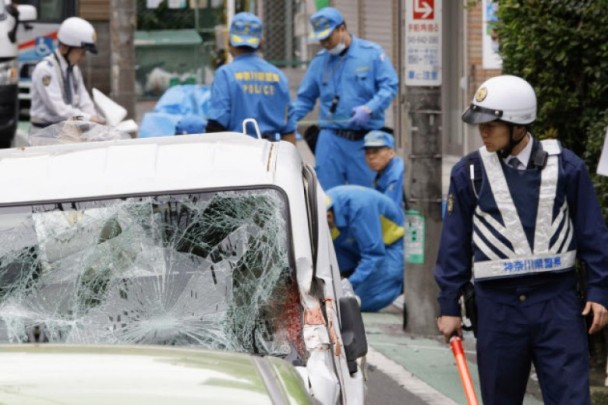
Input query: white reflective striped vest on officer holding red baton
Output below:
<box><xmin>473</xmin><ymin>140</ymin><xmax>576</xmax><ymax>280</ymax></box>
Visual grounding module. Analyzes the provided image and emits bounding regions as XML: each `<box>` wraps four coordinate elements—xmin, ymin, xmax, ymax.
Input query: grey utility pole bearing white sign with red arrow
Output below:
<box><xmin>401</xmin><ymin>0</ymin><xmax>443</xmax><ymax>335</ymax></box>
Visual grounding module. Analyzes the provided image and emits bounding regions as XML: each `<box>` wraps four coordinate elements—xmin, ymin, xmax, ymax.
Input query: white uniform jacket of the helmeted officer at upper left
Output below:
<box><xmin>30</xmin><ymin>50</ymin><xmax>97</xmax><ymax>128</ymax></box>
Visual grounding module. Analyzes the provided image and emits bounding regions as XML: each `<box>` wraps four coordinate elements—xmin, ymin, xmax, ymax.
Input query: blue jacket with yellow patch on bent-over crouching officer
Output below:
<box><xmin>327</xmin><ymin>185</ymin><xmax>405</xmax><ymax>289</ymax></box>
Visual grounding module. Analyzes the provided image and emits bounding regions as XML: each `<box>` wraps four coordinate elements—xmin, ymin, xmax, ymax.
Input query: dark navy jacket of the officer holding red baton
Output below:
<box><xmin>435</xmin><ymin>140</ymin><xmax>608</xmax><ymax>316</ymax></box>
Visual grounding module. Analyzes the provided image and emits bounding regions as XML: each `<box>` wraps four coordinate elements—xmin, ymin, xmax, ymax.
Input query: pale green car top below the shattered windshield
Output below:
<box><xmin>0</xmin><ymin>344</ymin><xmax>310</xmax><ymax>405</ymax></box>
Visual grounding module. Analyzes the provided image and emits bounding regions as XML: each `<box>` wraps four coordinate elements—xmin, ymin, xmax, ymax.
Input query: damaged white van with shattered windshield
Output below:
<box><xmin>0</xmin><ymin>124</ymin><xmax>367</xmax><ymax>404</ymax></box>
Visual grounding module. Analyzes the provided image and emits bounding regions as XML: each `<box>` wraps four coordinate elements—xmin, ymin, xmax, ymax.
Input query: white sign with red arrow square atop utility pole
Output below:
<box><xmin>404</xmin><ymin>0</ymin><xmax>442</xmax><ymax>86</ymax></box>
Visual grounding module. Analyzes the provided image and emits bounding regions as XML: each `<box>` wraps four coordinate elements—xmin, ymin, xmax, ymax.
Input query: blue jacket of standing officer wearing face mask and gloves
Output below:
<box><xmin>294</xmin><ymin>36</ymin><xmax>399</xmax><ymax>130</ymax></box>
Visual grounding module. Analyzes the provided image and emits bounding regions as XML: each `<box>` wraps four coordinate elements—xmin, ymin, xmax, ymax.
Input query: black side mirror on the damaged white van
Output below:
<box><xmin>340</xmin><ymin>296</ymin><xmax>367</xmax><ymax>374</ymax></box>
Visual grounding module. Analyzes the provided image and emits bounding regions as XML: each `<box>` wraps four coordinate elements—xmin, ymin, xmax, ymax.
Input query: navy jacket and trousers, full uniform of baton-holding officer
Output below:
<box><xmin>435</xmin><ymin>137</ymin><xmax>608</xmax><ymax>404</ymax></box>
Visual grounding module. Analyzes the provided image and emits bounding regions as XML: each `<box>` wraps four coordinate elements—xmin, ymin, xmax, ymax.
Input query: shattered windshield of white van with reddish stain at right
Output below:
<box><xmin>0</xmin><ymin>189</ymin><xmax>304</xmax><ymax>356</ymax></box>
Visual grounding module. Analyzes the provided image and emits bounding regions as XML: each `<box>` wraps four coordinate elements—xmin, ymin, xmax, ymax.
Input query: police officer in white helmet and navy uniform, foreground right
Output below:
<box><xmin>435</xmin><ymin>75</ymin><xmax>608</xmax><ymax>404</ymax></box>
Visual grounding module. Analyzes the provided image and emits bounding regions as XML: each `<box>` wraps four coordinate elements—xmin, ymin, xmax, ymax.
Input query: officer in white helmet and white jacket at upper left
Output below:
<box><xmin>30</xmin><ymin>17</ymin><xmax>104</xmax><ymax>130</ymax></box>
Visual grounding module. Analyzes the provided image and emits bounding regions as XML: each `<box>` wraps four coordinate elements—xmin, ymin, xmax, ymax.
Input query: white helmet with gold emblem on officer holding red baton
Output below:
<box><xmin>462</xmin><ymin>75</ymin><xmax>536</xmax><ymax>125</ymax></box>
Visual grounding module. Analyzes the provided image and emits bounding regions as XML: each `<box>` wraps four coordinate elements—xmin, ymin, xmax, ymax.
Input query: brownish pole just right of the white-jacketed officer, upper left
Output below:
<box><xmin>110</xmin><ymin>0</ymin><xmax>137</xmax><ymax>118</ymax></box>
